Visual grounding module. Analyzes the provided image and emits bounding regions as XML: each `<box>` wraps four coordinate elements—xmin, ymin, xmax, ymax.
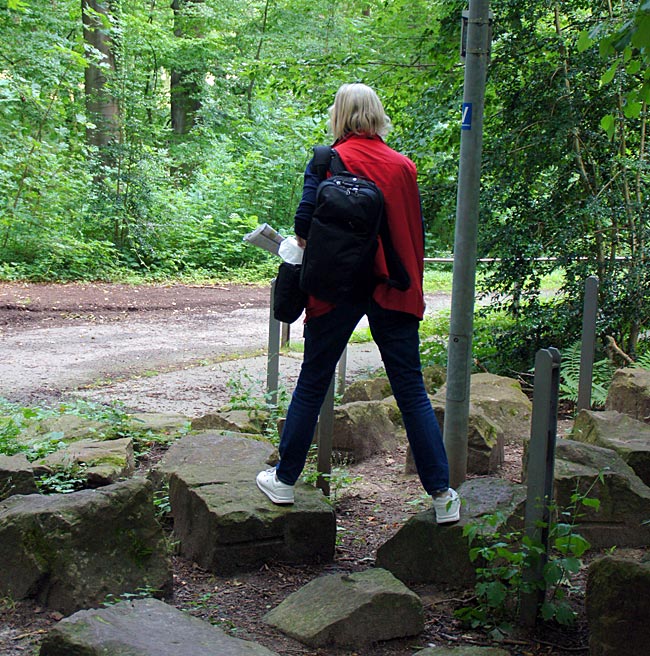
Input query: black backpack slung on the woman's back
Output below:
<box><xmin>300</xmin><ymin>146</ymin><xmax>410</xmax><ymax>303</ymax></box>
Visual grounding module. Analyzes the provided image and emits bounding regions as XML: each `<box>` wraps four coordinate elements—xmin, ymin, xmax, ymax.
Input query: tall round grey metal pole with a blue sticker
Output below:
<box><xmin>444</xmin><ymin>0</ymin><xmax>490</xmax><ymax>487</ymax></box>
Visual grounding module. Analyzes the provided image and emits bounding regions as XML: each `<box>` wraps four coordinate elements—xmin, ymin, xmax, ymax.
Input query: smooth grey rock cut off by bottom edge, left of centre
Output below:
<box><xmin>39</xmin><ymin>599</ymin><xmax>277</xmax><ymax>656</ymax></box>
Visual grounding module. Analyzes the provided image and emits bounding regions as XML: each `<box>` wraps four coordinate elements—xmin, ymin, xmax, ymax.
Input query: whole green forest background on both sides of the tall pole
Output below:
<box><xmin>0</xmin><ymin>0</ymin><xmax>650</xmax><ymax>374</ymax></box>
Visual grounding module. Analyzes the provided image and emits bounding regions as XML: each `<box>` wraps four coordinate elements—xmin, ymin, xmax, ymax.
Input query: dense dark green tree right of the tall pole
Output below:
<box><xmin>474</xmin><ymin>2</ymin><xmax>650</xmax><ymax>361</ymax></box>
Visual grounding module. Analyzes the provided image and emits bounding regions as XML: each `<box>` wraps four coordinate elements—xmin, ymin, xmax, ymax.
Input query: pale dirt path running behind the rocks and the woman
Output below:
<box><xmin>0</xmin><ymin>283</ymin><xmax>449</xmax><ymax>416</ymax></box>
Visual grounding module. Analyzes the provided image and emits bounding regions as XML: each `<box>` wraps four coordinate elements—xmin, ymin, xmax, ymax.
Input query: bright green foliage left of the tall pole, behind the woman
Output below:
<box><xmin>0</xmin><ymin>0</ymin><xmax>462</xmax><ymax>280</ymax></box>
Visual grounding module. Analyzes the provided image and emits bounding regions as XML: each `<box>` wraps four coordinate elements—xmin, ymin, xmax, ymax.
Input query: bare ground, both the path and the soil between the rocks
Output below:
<box><xmin>0</xmin><ymin>283</ymin><xmax>587</xmax><ymax>656</ymax></box>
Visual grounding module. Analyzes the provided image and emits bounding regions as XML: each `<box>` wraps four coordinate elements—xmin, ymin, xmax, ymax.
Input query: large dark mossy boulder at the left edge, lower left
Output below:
<box><xmin>0</xmin><ymin>478</ymin><xmax>172</xmax><ymax>614</ymax></box>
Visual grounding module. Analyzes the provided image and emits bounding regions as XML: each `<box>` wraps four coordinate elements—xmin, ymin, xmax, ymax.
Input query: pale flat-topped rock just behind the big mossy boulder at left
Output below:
<box><xmin>35</xmin><ymin>437</ymin><xmax>135</xmax><ymax>487</ymax></box>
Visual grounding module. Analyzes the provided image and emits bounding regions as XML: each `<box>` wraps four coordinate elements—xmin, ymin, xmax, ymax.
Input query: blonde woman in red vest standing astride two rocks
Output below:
<box><xmin>257</xmin><ymin>84</ymin><xmax>460</xmax><ymax>523</ymax></box>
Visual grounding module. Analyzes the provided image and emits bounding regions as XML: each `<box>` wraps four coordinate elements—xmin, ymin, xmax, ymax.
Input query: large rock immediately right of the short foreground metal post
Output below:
<box><xmin>555</xmin><ymin>439</ymin><xmax>650</xmax><ymax>549</ymax></box>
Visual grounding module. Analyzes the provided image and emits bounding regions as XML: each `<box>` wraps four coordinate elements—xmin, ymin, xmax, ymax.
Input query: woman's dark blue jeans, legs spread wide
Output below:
<box><xmin>277</xmin><ymin>300</ymin><xmax>449</xmax><ymax>494</ymax></box>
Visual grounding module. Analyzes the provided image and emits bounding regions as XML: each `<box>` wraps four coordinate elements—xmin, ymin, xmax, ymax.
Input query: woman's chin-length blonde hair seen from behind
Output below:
<box><xmin>329</xmin><ymin>82</ymin><xmax>390</xmax><ymax>141</ymax></box>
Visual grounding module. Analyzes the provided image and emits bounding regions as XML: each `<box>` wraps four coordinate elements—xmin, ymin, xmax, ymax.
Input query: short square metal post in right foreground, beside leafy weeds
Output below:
<box><xmin>520</xmin><ymin>348</ymin><xmax>560</xmax><ymax>626</ymax></box>
